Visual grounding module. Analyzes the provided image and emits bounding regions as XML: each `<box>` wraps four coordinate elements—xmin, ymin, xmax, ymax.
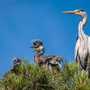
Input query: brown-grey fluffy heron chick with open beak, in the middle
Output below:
<box><xmin>30</xmin><ymin>40</ymin><xmax>62</xmax><ymax>71</ymax></box>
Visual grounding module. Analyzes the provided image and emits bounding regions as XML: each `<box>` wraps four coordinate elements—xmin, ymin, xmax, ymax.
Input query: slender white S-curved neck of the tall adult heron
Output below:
<box><xmin>79</xmin><ymin>15</ymin><xmax>87</xmax><ymax>40</ymax></box>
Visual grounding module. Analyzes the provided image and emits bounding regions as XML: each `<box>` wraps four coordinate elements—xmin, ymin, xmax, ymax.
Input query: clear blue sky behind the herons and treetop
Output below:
<box><xmin>0</xmin><ymin>0</ymin><xmax>90</xmax><ymax>75</ymax></box>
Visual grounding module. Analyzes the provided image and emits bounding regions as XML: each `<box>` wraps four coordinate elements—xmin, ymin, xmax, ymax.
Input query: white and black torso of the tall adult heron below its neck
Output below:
<box><xmin>75</xmin><ymin>37</ymin><xmax>88</xmax><ymax>69</ymax></box>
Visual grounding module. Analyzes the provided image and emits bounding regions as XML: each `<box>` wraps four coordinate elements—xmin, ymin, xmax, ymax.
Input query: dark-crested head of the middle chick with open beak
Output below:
<box><xmin>30</xmin><ymin>40</ymin><xmax>44</xmax><ymax>52</ymax></box>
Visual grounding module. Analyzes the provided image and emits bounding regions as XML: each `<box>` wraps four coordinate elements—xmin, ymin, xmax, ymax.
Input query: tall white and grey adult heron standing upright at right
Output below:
<box><xmin>62</xmin><ymin>9</ymin><xmax>90</xmax><ymax>78</ymax></box>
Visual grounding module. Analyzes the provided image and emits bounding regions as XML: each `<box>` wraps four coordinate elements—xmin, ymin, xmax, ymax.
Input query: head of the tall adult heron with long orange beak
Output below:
<box><xmin>62</xmin><ymin>9</ymin><xmax>87</xmax><ymax>18</ymax></box>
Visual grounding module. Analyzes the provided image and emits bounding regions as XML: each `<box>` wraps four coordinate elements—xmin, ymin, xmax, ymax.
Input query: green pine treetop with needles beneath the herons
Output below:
<box><xmin>0</xmin><ymin>61</ymin><xmax>90</xmax><ymax>90</ymax></box>
